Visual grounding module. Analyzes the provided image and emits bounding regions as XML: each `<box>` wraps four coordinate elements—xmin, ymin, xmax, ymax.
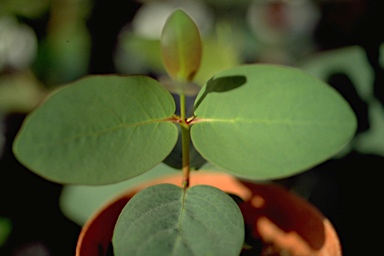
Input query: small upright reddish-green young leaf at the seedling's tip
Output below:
<box><xmin>160</xmin><ymin>10</ymin><xmax>202</xmax><ymax>82</ymax></box>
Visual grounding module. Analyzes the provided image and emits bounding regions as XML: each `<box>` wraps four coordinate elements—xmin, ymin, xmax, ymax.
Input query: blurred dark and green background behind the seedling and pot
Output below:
<box><xmin>0</xmin><ymin>0</ymin><xmax>384</xmax><ymax>256</ymax></box>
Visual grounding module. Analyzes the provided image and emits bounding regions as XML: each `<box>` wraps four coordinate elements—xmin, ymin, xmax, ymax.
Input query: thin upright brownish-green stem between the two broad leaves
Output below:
<box><xmin>180</xmin><ymin>92</ymin><xmax>190</xmax><ymax>189</ymax></box>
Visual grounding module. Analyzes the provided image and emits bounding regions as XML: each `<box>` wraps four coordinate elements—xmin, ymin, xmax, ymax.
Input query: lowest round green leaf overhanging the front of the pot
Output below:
<box><xmin>112</xmin><ymin>184</ymin><xmax>244</xmax><ymax>256</ymax></box>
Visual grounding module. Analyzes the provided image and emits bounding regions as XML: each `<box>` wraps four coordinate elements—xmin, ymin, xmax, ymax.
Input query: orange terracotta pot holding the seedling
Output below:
<box><xmin>76</xmin><ymin>172</ymin><xmax>341</xmax><ymax>256</ymax></box>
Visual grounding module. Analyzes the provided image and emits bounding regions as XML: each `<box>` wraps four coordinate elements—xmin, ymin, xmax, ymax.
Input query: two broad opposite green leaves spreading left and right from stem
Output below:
<box><xmin>14</xmin><ymin>65</ymin><xmax>356</xmax><ymax>184</ymax></box>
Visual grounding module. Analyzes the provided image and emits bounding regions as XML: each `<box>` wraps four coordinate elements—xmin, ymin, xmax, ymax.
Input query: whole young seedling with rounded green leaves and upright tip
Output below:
<box><xmin>14</xmin><ymin>10</ymin><xmax>356</xmax><ymax>255</ymax></box>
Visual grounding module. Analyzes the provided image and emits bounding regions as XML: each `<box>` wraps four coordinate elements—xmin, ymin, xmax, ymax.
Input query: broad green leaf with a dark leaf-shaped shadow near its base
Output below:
<box><xmin>191</xmin><ymin>65</ymin><xmax>356</xmax><ymax>179</ymax></box>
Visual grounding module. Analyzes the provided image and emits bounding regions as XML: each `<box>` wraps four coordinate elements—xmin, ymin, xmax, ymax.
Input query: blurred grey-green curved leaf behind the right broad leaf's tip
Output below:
<box><xmin>298</xmin><ymin>44</ymin><xmax>384</xmax><ymax>156</ymax></box>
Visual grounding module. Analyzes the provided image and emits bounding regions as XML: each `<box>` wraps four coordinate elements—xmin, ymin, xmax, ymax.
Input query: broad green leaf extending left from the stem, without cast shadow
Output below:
<box><xmin>14</xmin><ymin>76</ymin><xmax>178</xmax><ymax>185</ymax></box>
